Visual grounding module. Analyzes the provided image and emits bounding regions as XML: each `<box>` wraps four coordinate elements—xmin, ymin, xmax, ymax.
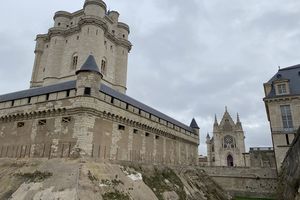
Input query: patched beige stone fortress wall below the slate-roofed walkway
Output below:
<box><xmin>0</xmin><ymin>93</ymin><xmax>199</xmax><ymax>164</ymax></box>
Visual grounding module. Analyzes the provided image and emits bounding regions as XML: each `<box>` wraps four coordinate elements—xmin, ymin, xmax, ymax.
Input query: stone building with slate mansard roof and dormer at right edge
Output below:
<box><xmin>264</xmin><ymin>65</ymin><xmax>300</xmax><ymax>171</ymax></box>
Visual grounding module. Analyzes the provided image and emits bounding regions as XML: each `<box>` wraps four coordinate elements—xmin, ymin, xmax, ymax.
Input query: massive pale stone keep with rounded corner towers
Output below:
<box><xmin>31</xmin><ymin>0</ymin><xmax>132</xmax><ymax>93</ymax></box>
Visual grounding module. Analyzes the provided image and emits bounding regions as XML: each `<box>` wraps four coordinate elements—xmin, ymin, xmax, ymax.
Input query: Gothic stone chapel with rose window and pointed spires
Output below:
<box><xmin>206</xmin><ymin>108</ymin><xmax>245</xmax><ymax>167</ymax></box>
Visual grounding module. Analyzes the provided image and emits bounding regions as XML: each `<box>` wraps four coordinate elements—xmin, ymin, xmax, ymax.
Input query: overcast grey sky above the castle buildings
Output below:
<box><xmin>0</xmin><ymin>0</ymin><xmax>300</xmax><ymax>154</ymax></box>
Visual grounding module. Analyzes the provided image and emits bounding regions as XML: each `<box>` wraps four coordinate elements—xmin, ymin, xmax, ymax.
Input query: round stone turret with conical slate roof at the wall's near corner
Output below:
<box><xmin>76</xmin><ymin>55</ymin><xmax>103</xmax><ymax>98</ymax></box>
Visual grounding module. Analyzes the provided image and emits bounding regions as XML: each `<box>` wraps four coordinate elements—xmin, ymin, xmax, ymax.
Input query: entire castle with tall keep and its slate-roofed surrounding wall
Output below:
<box><xmin>0</xmin><ymin>0</ymin><xmax>199</xmax><ymax>165</ymax></box>
